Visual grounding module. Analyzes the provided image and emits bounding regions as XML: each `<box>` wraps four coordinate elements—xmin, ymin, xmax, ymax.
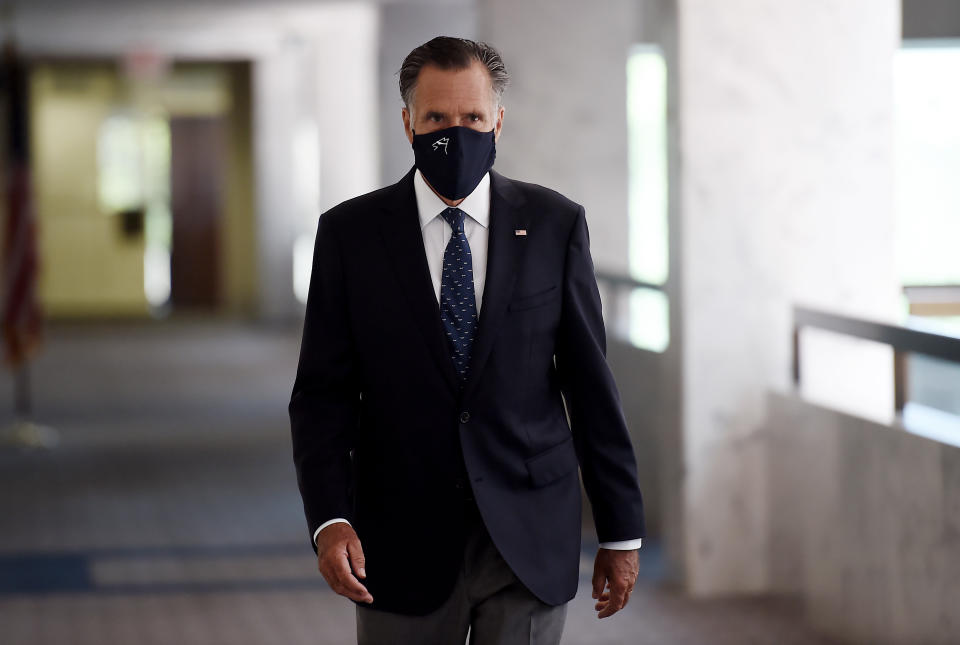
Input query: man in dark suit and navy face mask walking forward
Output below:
<box><xmin>289</xmin><ymin>37</ymin><xmax>644</xmax><ymax>644</ymax></box>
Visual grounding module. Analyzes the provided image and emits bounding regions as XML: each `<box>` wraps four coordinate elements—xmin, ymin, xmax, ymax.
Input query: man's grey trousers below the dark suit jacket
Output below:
<box><xmin>357</xmin><ymin>498</ymin><xmax>567</xmax><ymax>645</ymax></box>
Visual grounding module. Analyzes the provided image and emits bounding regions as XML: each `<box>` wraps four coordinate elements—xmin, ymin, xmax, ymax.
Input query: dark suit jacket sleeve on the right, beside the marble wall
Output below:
<box><xmin>555</xmin><ymin>206</ymin><xmax>645</xmax><ymax>542</ymax></box>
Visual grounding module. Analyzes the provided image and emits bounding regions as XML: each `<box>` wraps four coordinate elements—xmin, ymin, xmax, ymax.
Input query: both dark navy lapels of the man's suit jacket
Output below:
<box><xmin>380</xmin><ymin>168</ymin><xmax>527</xmax><ymax>400</ymax></box>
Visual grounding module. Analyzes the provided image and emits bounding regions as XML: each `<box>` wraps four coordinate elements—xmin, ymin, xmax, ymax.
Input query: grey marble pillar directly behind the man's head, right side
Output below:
<box><xmin>478</xmin><ymin>0</ymin><xmax>639</xmax><ymax>273</ymax></box>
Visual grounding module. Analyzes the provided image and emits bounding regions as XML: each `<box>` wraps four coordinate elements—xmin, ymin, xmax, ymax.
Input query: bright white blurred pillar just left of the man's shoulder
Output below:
<box><xmin>254</xmin><ymin>3</ymin><xmax>380</xmax><ymax>320</ymax></box>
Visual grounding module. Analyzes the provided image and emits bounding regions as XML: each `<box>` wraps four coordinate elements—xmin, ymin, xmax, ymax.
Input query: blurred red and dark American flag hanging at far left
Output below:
<box><xmin>0</xmin><ymin>42</ymin><xmax>42</xmax><ymax>367</ymax></box>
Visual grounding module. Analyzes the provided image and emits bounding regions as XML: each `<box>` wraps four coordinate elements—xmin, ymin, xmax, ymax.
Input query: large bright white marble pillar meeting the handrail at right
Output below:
<box><xmin>678</xmin><ymin>0</ymin><xmax>899</xmax><ymax>593</ymax></box>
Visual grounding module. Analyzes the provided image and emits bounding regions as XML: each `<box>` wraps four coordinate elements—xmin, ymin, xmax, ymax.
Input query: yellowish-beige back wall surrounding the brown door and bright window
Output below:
<box><xmin>31</xmin><ymin>62</ymin><xmax>256</xmax><ymax>318</ymax></box>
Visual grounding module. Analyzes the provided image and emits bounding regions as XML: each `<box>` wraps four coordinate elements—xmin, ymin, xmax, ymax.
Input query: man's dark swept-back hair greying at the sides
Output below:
<box><xmin>398</xmin><ymin>36</ymin><xmax>510</xmax><ymax>110</ymax></box>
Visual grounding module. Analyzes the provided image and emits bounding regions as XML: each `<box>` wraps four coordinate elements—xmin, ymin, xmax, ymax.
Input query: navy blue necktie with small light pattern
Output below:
<box><xmin>440</xmin><ymin>208</ymin><xmax>477</xmax><ymax>387</ymax></box>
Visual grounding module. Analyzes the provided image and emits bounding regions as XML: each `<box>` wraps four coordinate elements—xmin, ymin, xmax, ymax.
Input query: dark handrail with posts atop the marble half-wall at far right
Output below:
<box><xmin>793</xmin><ymin>306</ymin><xmax>960</xmax><ymax>413</ymax></box>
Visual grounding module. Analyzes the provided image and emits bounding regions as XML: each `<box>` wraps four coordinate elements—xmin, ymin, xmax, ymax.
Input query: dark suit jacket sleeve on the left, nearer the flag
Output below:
<box><xmin>289</xmin><ymin>213</ymin><xmax>360</xmax><ymax>551</ymax></box>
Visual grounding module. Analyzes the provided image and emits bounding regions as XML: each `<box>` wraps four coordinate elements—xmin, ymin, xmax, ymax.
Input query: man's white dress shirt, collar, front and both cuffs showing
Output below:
<box><xmin>313</xmin><ymin>169</ymin><xmax>641</xmax><ymax>550</ymax></box>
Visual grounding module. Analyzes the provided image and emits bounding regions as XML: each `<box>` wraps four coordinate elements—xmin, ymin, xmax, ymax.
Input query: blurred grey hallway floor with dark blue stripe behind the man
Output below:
<box><xmin>0</xmin><ymin>320</ymin><xmax>831</xmax><ymax>645</ymax></box>
